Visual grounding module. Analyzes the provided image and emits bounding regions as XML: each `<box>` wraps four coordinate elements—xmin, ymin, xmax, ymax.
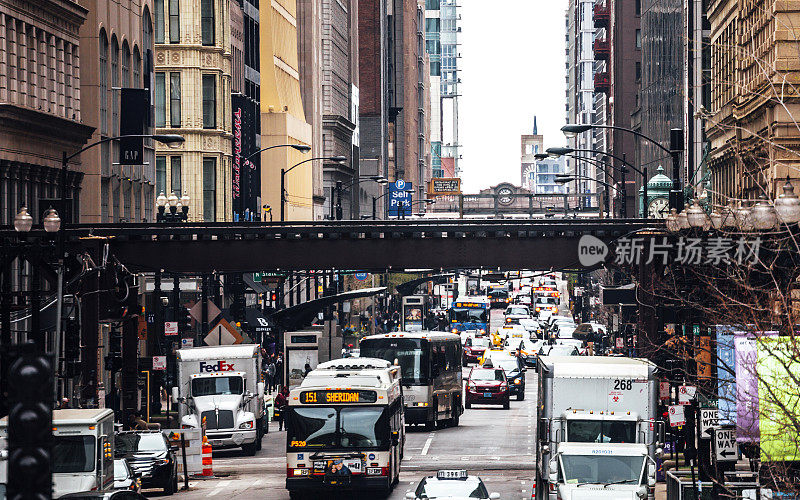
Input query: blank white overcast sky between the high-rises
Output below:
<box><xmin>459</xmin><ymin>0</ymin><xmax>567</xmax><ymax>193</ymax></box>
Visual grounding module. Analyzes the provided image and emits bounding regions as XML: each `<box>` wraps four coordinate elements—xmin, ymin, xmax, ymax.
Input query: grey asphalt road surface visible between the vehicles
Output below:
<box><xmin>167</xmin><ymin>309</ymin><xmax>536</xmax><ymax>500</ymax></box>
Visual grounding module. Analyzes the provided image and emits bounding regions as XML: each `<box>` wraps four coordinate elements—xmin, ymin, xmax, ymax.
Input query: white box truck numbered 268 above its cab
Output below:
<box><xmin>535</xmin><ymin>356</ymin><xmax>663</xmax><ymax>498</ymax></box>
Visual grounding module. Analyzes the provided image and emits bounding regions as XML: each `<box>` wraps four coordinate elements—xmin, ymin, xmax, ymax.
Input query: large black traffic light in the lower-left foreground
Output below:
<box><xmin>7</xmin><ymin>343</ymin><xmax>53</xmax><ymax>499</ymax></box>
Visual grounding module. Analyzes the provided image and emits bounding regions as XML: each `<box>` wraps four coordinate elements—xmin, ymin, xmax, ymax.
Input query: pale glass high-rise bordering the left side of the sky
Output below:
<box><xmin>425</xmin><ymin>0</ymin><xmax>461</xmax><ymax>177</ymax></box>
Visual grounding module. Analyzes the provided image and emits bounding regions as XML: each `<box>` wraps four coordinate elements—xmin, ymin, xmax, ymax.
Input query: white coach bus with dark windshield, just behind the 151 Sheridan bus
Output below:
<box><xmin>360</xmin><ymin>332</ymin><xmax>464</xmax><ymax>429</ymax></box>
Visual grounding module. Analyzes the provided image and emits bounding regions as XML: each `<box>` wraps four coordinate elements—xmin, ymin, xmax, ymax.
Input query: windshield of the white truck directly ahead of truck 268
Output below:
<box><xmin>561</xmin><ymin>455</ymin><xmax>644</xmax><ymax>484</ymax></box>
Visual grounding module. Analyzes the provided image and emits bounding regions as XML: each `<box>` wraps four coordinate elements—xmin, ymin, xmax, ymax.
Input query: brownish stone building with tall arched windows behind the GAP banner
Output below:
<box><xmin>79</xmin><ymin>0</ymin><xmax>156</xmax><ymax>222</ymax></box>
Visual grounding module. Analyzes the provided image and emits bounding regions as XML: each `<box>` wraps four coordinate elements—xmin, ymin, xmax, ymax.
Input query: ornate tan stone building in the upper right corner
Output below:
<box><xmin>705</xmin><ymin>0</ymin><xmax>800</xmax><ymax>199</ymax></box>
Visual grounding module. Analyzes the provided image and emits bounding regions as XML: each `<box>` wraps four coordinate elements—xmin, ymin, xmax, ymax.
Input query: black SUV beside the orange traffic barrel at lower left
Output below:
<box><xmin>114</xmin><ymin>431</ymin><xmax>178</xmax><ymax>495</ymax></box>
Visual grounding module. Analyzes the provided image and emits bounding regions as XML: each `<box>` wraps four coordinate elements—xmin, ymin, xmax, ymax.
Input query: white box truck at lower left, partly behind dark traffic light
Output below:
<box><xmin>0</xmin><ymin>408</ymin><xmax>114</xmax><ymax>498</ymax></box>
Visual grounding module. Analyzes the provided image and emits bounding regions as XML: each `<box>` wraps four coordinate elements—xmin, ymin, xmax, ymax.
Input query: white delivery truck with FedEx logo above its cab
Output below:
<box><xmin>172</xmin><ymin>344</ymin><xmax>267</xmax><ymax>455</ymax></box>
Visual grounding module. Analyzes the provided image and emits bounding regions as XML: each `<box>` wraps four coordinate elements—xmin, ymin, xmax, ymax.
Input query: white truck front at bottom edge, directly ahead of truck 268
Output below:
<box><xmin>543</xmin><ymin>443</ymin><xmax>656</xmax><ymax>500</ymax></box>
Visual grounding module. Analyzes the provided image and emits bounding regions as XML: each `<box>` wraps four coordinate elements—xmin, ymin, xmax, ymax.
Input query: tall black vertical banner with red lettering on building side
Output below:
<box><xmin>231</xmin><ymin>94</ymin><xmax>261</xmax><ymax>221</ymax></box>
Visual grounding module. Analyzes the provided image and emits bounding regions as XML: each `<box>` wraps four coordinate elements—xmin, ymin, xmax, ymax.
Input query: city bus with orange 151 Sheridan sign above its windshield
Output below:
<box><xmin>286</xmin><ymin>358</ymin><xmax>405</xmax><ymax>499</ymax></box>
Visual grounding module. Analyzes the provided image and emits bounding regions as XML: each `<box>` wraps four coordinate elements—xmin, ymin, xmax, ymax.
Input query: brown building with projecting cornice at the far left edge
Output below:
<box><xmin>0</xmin><ymin>0</ymin><xmax>94</xmax><ymax>225</ymax></box>
